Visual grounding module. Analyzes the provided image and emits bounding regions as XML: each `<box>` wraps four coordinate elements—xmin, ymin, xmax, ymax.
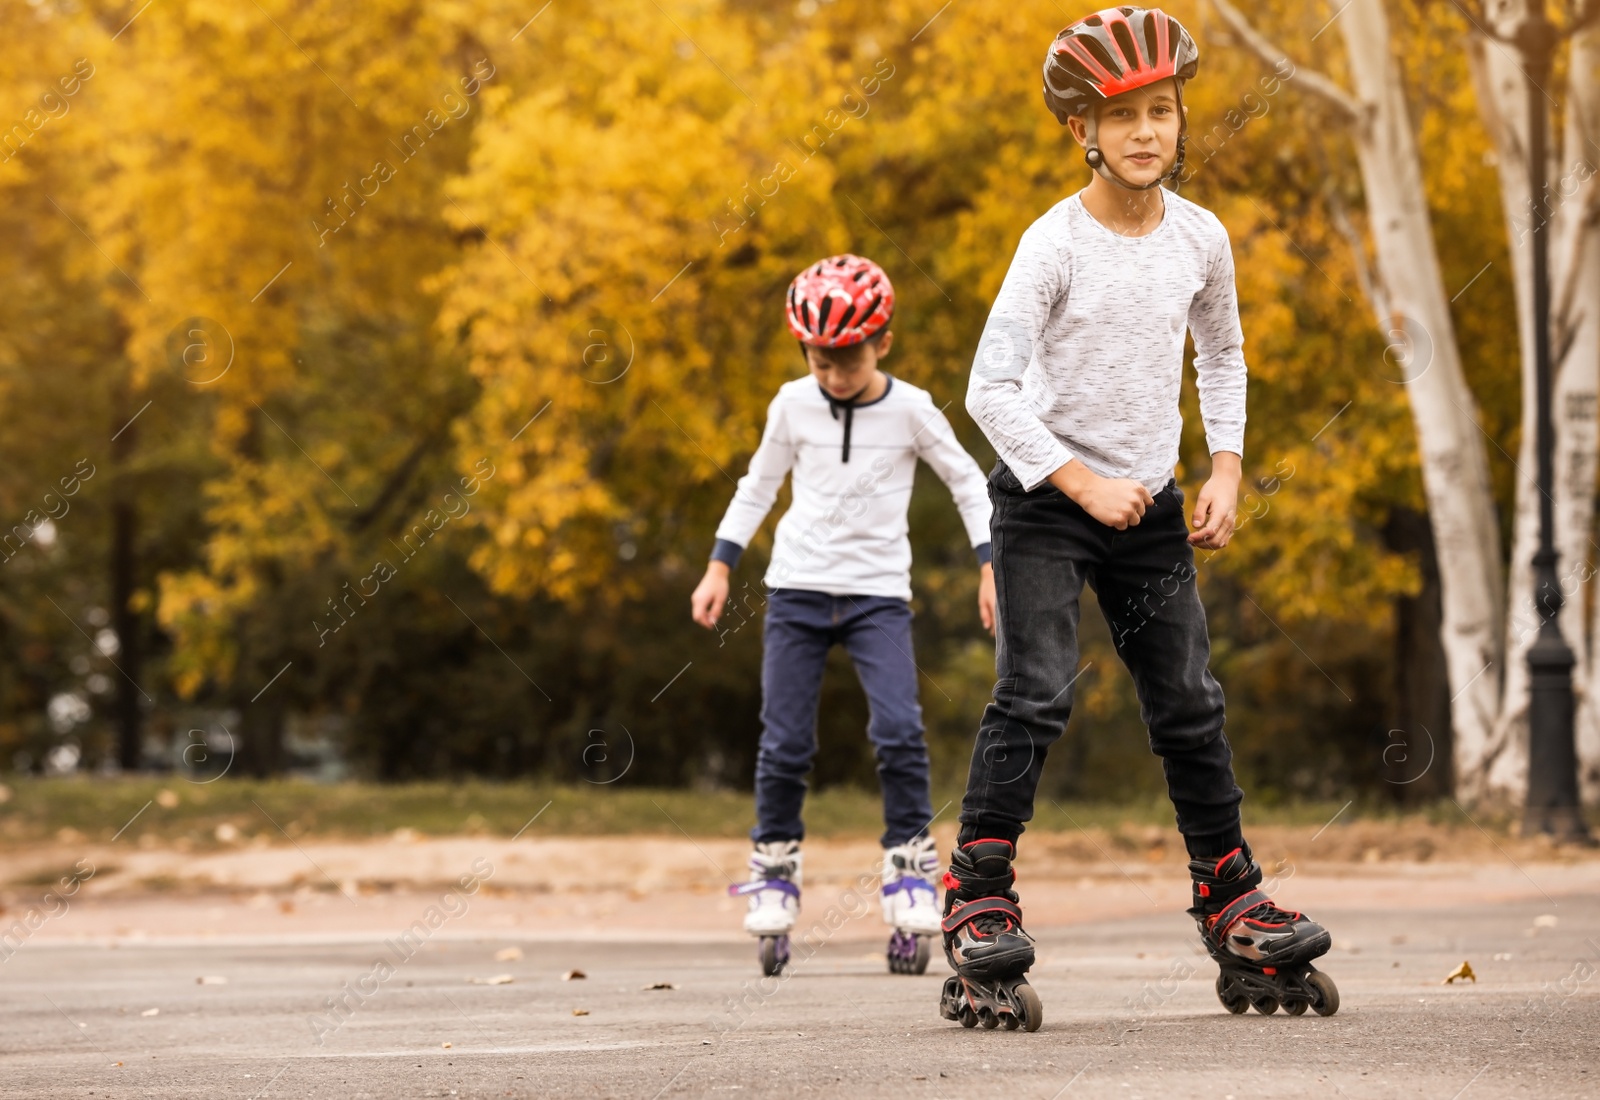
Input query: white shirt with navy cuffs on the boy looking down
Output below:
<box><xmin>712</xmin><ymin>376</ymin><xmax>989</xmax><ymax>600</ymax></box>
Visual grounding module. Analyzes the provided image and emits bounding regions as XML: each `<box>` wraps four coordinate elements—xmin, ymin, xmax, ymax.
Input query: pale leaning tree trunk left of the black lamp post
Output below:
<box><xmin>1339</xmin><ymin>0</ymin><xmax>1504</xmax><ymax>798</ymax></box>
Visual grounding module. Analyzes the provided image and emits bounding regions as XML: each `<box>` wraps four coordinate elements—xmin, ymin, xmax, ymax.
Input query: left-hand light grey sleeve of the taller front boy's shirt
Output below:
<box><xmin>966</xmin><ymin>224</ymin><xmax>1074</xmax><ymax>489</ymax></box>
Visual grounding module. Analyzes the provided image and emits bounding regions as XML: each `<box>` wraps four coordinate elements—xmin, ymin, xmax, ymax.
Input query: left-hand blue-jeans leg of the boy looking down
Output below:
<box><xmin>750</xmin><ymin>588</ymin><xmax>834</xmax><ymax>844</ymax></box>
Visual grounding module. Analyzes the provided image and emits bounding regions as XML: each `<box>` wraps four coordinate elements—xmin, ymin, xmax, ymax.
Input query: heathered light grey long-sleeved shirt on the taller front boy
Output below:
<box><xmin>966</xmin><ymin>193</ymin><xmax>1245</xmax><ymax>492</ymax></box>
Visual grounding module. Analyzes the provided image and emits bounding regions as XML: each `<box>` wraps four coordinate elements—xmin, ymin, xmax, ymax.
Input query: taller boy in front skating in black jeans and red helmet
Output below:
<box><xmin>941</xmin><ymin>6</ymin><xmax>1339</xmax><ymax>1031</ymax></box>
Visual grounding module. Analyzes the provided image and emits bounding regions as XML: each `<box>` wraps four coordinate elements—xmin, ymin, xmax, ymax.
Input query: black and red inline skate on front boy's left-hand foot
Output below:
<box><xmin>939</xmin><ymin>839</ymin><xmax>1045</xmax><ymax>1031</ymax></box>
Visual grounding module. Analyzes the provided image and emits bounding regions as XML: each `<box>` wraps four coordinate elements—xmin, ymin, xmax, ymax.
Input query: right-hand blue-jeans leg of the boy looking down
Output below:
<box><xmin>837</xmin><ymin>596</ymin><xmax>933</xmax><ymax>847</ymax></box>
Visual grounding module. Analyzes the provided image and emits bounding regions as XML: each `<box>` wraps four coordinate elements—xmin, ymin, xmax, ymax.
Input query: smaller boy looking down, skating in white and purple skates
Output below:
<box><xmin>691</xmin><ymin>256</ymin><xmax>994</xmax><ymax>975</ymax></box>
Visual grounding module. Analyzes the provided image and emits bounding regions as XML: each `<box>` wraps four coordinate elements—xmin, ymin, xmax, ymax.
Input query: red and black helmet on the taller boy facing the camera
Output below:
<box><xmin>1045</xmin><ymin>8</ymin><xmax>1200</xmax><ymax>125</ymax></box>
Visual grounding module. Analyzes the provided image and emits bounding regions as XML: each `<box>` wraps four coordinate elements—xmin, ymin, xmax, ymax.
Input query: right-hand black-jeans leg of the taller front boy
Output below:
<box><xmin>1093</xmin><ymin>484</ymin><xmax>1243</xmax><ymax>857</ymax></box>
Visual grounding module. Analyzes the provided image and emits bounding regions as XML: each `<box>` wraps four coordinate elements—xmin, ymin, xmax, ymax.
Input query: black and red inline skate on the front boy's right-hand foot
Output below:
<box><xmin>1189</xmin><ymin>846</ymin><xmax>1339</xmax><ymax>1015</ymax></box>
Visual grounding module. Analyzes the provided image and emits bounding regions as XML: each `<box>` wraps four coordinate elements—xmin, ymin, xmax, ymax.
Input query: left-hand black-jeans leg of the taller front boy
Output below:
<box><xmin>960</xmin><ymin>464</ymin><xmax>1109</xmax><ymax>843</ymax></box>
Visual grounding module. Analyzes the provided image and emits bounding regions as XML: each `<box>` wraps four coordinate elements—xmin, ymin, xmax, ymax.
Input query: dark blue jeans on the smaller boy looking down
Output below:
<box><xmin>750</xmin><ymin>588</ymin><xmax>933</xmax><ymax>847</ymax></box>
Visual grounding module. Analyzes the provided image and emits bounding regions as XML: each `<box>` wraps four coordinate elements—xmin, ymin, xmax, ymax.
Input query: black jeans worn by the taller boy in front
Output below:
<box><xmin>962</xmin><ymin>462</ymin><xmax>1243</xmax><ymax>855</ymax></box>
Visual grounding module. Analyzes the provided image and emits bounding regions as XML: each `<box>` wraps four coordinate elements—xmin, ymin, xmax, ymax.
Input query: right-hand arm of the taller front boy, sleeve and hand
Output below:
<box><xmin>1189</xmin><ymin>227</ymin><xmax>1246</xmax><ymax>550</ymax></box>
